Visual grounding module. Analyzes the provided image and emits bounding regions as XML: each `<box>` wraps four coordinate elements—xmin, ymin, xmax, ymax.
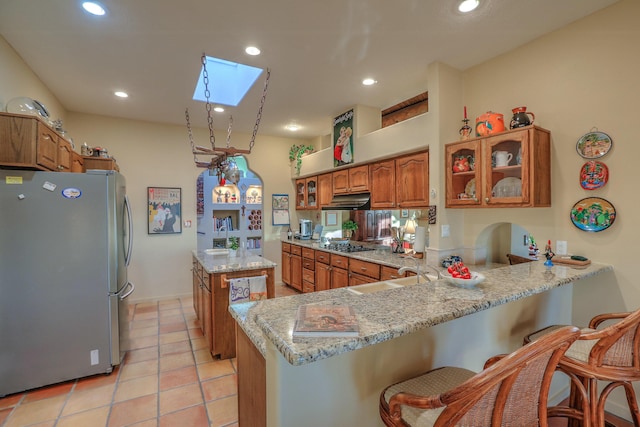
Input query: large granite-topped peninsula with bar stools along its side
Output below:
<box><xmin>230</xmin><ymin>261</ymin><xmax>613</xmax><ymax>427</ymax></box>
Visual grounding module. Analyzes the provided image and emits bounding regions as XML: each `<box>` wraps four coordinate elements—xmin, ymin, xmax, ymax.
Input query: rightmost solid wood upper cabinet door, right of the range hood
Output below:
<box><xmin>396</xmin><ymin>151</ymin><xmax>429</xmax><ymax>208</ymax></box>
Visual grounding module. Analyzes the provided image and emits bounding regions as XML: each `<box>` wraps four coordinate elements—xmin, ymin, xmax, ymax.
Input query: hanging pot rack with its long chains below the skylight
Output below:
<box><xmin>185</xmin><ymin>53</ymin><xmax>271</xmax><ymax>185</ymax></box>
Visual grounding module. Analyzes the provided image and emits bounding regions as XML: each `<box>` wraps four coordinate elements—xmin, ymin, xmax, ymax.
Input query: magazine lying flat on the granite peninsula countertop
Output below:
<box><xmin>293</xmin><ymin>304</ymin><xmax>360</xmax><ymax>337</ymax></box>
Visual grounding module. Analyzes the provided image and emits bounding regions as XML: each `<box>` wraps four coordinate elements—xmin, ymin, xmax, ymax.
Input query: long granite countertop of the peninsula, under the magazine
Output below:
<box><xmin>229</xmin><ymin>260</ymin><xmax>613</xmax><ymax>365</ymax></box>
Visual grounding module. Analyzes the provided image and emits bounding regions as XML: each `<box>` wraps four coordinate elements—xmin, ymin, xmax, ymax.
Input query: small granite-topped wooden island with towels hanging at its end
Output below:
<box><xmin>192</xmin><ymin>250</ymin><xmax>276</xmax><ymax>359</ymax></box>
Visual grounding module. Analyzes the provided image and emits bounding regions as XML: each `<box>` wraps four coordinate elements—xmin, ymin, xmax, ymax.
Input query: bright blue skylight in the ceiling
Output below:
<box><xmin>193</xmin><ymin>56</ymin><xmax>263</xmax><ymax>107</ymax></box>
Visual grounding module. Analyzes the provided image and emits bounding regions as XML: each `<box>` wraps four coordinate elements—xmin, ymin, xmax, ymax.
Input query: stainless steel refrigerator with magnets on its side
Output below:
<box><xmin>0</xmin><ymin>170</ymin><xmax>134</xmax><ymax>397</ymax></box>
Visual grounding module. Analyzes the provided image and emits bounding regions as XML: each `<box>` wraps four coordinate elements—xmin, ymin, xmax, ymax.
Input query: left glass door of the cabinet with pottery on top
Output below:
<box><xmin>445</xmin><ymin>140</ymin><xmax>484</xmax><ymax>207</ymax></box>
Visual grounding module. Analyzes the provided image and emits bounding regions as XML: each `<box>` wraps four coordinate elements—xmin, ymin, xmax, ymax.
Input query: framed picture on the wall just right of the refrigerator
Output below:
<box><xmin>147</xmin><ymin>187</ymin><xmax>182</xmax><ymax>234</ymax></box>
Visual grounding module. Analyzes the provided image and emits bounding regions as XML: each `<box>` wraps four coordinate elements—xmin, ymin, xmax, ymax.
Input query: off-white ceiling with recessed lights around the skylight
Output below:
<box><xmin>0</xmin><ymin>0</ymin><xmax>617</xmax><ymax>137</ymax></box>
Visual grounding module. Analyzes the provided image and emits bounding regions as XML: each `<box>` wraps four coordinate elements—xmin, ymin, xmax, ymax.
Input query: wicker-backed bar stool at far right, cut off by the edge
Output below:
<box><xmin>524</xmin><ymin>309</ymin><xmax>640</xmax><ymax>427</ymax></box>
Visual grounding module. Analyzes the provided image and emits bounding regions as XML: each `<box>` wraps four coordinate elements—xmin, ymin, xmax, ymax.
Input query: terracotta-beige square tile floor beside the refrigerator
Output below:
<box><xmin>0</xmin><ymin>286</ymin><xmax>296</xmax><ymax>427</ymax></box>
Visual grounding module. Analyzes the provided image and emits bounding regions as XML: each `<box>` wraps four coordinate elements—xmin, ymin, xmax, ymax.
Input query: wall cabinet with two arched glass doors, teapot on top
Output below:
<box><xmin>445</xmin><ymin>126</ymin><xmax>551</xmax><ymax>208</ymax></box>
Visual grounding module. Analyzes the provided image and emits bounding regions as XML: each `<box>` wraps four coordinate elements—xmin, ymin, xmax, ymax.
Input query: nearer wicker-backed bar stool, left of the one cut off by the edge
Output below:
<box><xmin>379</xmin><ymin>326</ymin><xmax>590</xmax><ymax>427</ymax></box>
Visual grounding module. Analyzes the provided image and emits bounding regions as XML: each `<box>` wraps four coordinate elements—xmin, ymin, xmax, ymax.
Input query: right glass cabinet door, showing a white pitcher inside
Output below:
<box><xmin>482</xmin><ymin>131</ymin><xmax>529</xmax><ymax>206</ymax></box>
